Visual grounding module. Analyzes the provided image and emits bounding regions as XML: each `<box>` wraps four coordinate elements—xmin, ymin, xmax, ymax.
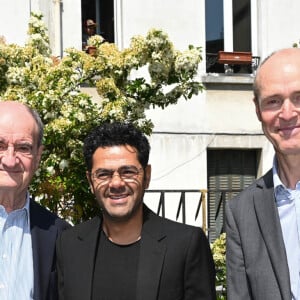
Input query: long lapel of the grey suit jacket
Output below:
<box><xmin>254</xmin><ymin>173</ymin><xmax>290</xmax><ymax>299</ymax></box>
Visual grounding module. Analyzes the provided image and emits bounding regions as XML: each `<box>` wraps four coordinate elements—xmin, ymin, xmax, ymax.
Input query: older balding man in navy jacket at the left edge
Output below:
<box><xmin>0</xmin><ymin>101</ymin><xmax>69</xmax><ymax>300</ymax></box>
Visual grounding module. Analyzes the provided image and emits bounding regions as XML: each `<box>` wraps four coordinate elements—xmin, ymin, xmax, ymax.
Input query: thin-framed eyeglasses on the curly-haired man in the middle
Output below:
<box><xmin>91</xmin><ymin>166</ymin><xmax>143</xmax><ymax>184</ymax></box>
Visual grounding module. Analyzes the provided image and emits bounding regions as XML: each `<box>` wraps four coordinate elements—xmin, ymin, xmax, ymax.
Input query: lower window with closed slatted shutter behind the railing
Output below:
<box><xmin>207</xmin><ymin>149</ymin><xmax>260</xmax><ymax>242</ymax></box>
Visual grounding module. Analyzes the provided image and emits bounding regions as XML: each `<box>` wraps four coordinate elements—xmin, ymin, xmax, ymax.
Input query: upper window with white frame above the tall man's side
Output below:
<box><xmin>205</xmin><ymin>0</ymin><xmax>253</xmax><ymax>73</ymax></box>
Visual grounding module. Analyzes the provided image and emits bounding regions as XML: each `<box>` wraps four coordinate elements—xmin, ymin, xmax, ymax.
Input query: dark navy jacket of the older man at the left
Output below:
<box><xmin>29</xmin><ymin>199</ymin><xmax>70</xmax><ymax>300</ymax></box>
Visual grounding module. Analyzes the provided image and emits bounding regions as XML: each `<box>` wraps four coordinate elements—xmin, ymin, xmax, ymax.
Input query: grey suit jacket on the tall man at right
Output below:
<box><xmin>225</xmin><ymin>170</ymin><xmax>292</xmax><ymax>300</ymax></box>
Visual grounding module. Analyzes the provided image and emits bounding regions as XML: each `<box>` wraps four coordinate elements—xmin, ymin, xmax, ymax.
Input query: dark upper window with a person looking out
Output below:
<box><xmin>81</xmin><ymin>0</ymin><xmax>115</xmax><ymax>43</ymax></box>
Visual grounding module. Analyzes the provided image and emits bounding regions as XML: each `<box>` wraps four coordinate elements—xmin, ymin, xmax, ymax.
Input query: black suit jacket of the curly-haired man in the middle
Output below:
<box><xmin>57</xmin><ymin>206</ymin><xmax>216</xmax><ymax>300</ymax></box>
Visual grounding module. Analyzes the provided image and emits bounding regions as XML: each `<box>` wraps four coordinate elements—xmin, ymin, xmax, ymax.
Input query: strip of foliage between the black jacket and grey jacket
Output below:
<box><xmin>211</xmin><ymin>233</ymin><xmax>226</xmax><ymax>300</ymax></box>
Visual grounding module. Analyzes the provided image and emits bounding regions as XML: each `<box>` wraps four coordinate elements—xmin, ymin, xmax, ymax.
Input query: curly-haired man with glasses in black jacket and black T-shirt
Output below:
<box><xmin>57</xmin><ymin>122</ymin><xmax>216</xmax><ymax>300</ymax></box>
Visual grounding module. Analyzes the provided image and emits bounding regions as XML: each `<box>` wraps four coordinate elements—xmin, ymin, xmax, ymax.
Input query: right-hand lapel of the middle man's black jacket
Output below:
<box><xmin>136</xmin><ymin>207</ymin><xmax>166</xmax><ymax>300</ymax></box>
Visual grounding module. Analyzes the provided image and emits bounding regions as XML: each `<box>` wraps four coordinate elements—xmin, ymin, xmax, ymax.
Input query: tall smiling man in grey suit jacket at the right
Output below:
<box><xmin>226</xmin><ymin>48</ymin><xmax>300</xmax><ymax>300</ymax></box>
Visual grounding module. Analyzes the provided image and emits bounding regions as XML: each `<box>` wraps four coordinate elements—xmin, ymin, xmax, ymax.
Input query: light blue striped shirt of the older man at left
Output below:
<box><xmin>0</xmin><ymin>195</ymin><xmax>33</xmax><ymax>300</ymax></box>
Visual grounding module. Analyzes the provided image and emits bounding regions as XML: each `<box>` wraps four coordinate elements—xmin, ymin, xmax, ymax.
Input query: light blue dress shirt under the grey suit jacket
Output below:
<box><xmin>273</xmin><ymin>159</ymin><xmax>300</xmax><ymax>300</ymax></box>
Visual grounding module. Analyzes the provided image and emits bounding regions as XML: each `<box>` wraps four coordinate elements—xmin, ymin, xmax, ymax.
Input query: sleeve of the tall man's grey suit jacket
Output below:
<box><xmin>225</xmin><ymin>203</ymin><xmax>252</xmax><ymax>300</ymax></box>
